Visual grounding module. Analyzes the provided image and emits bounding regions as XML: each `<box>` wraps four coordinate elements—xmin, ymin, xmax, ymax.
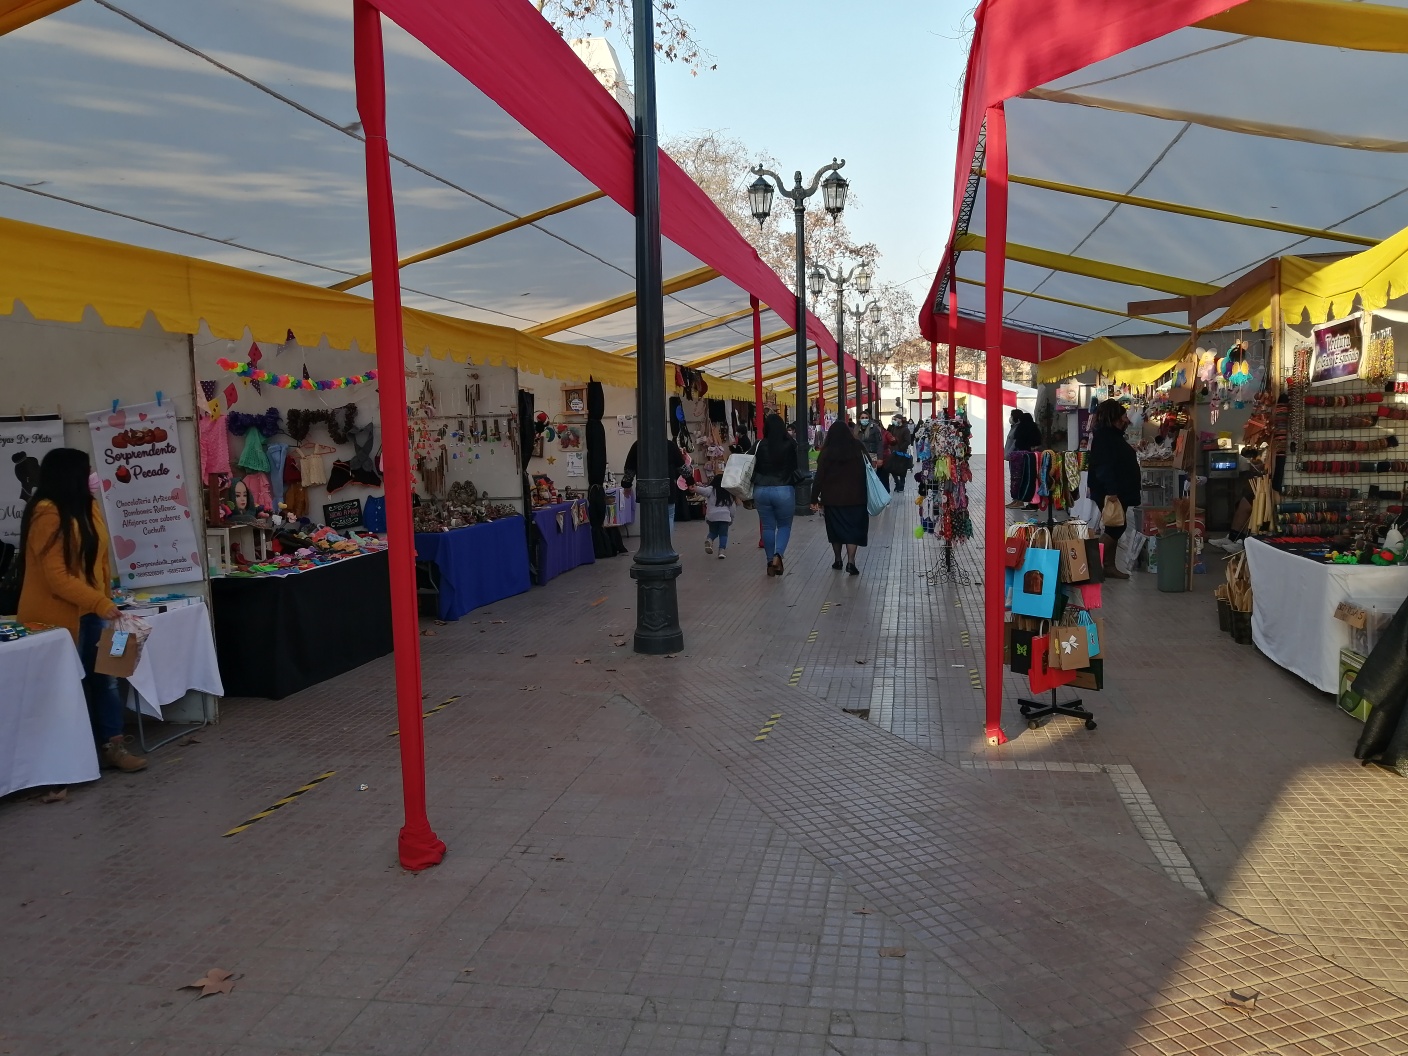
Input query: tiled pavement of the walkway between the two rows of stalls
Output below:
<box><xmin>8</xmin><ymin>459</ymin><xmax>1408</xmax><ymax>1056</ymax></box>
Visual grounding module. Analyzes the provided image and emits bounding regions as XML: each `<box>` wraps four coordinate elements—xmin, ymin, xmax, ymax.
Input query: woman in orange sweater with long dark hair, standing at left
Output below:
<box><xmin>18</xmin><ymin>448</ymin><xmax>146</xmax><ymax>772</ymax></box>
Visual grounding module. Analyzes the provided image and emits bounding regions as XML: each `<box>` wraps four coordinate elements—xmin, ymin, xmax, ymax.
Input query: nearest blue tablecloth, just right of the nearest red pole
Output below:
<box><xmin>415</xmin><ymin>517</ymin><xmax>531</xmax><ymax>620</ymax></box>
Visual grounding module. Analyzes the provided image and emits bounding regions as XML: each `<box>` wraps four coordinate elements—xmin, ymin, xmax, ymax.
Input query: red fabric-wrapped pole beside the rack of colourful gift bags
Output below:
<box><xmin>985</xmin><ymin>104</ymin><xmax>1007</xmax><ymax>745</ymax></box>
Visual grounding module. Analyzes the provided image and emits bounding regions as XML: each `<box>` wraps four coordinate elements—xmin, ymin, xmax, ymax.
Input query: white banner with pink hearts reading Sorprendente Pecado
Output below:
<box><xmin>87</xmin><ymin>400</ymin><xmax>204</xmax><ymax>590</ymax></box>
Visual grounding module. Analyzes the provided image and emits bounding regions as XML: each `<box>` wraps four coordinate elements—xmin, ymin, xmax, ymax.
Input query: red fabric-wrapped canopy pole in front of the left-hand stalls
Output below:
<box><xmin>352</xmin><ymin>0</ymin><xmax>445</xmax><ymax>870</ymax></box>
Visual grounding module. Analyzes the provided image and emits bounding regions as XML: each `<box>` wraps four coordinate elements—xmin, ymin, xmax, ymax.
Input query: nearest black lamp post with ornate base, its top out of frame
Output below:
<box><xmin>631</xmin><ymin>0</ymin><xmax>684</xmax><ymax>656</ymax></box>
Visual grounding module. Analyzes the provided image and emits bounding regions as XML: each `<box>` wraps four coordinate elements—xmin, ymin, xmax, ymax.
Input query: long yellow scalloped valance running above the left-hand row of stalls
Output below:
<box><xmin>0</xmin><ymin>215</ymin><xmax>794</xmax><ymax>400</ymax></box>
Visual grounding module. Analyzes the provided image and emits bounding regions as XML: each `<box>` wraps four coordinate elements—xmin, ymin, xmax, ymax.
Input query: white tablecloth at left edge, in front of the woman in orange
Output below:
<box><xmin>0</xmin><ymin>631</ymin><xmax>97</xmax><ymax>796</ymax></box>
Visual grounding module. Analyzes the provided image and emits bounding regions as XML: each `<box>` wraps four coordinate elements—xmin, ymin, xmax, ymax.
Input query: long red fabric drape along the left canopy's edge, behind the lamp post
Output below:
<box><xmin>369</xmin><ymin>0</ymin><xmax>836</xmax><ymax>362</ymax></box>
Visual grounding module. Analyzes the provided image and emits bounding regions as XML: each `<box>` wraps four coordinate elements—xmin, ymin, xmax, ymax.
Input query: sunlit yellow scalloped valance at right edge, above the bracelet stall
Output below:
<box><xmin>1209</xmin><ymin>228</ymin><xmax>1408</xmax><ymax>329</ymax></box>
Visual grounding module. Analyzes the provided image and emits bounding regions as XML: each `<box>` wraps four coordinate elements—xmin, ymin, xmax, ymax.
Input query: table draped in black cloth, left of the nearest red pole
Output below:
<box><xmin>210</xmin><ymin>551</ymin><xmax>391</xmax><ymax>700</ymax></box>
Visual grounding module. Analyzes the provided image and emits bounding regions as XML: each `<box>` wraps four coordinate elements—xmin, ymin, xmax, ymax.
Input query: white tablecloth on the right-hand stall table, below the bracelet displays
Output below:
<box><xmin>1246</xmin><ymin>539</ymin><xmax>1408</xmax><ymax>693</ymax></box>
